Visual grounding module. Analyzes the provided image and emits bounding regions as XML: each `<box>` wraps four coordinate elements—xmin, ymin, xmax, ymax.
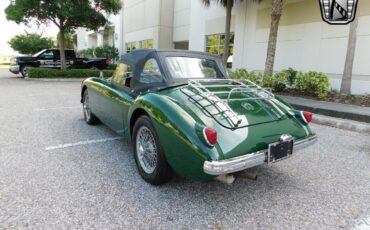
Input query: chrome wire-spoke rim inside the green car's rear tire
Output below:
<box><xmin>136</xmin><ymin>126</ymin><xmax>157</xmax><ymax>174</ymax></box>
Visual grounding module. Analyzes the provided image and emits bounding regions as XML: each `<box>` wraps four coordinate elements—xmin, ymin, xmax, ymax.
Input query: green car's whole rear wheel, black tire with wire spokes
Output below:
<box><xmin>132</xmin><ymin>115</ymin><xmax>173</xmax><ymax>185</ymax></box>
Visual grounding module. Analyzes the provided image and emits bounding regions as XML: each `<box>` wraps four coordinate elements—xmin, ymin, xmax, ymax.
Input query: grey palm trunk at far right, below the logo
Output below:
<box><xmin>340</xmin><ymin>15</ymin><xmax>359</xmax><ymax>94</ymax></box>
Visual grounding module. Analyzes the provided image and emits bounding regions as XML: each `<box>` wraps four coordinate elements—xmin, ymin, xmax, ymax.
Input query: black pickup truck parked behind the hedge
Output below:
<box><xmin>9</xmin><ymin>49</ymin><xmax>110</xmax><ymax>77</ymax></box>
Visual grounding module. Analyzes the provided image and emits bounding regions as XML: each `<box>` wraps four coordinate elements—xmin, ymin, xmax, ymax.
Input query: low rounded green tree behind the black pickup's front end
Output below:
<box><xmin>9</xmin><ymin>33</ymin><xmax>54</xmax><ymax>55</ymax></box>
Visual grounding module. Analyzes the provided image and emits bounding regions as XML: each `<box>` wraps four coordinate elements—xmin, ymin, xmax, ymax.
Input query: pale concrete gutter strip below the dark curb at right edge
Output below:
<box><xmin>312</xmin><ymin>114</ymin><xmax>370</xmax><ymax>134</ymax></box>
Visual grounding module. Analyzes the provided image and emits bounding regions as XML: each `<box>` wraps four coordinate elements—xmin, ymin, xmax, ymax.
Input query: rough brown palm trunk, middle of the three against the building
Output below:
<box><xmin>264</xmin><ymin>0</ymin><xmax>284</xmax><ymax>76</ymax></box>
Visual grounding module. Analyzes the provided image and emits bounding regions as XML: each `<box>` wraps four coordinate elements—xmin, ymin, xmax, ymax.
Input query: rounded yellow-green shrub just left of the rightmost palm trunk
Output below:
<box><xmin>296</xmin><ymin>71</ymin><xmax>330</xmax><ymax>98</ymax></box>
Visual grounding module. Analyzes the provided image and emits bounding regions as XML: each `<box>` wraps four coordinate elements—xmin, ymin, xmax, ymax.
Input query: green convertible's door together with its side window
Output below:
<box><xmin>100</xmin><ymin>63</ymin><xmax>134</xmax><ymax>135</ymax></box>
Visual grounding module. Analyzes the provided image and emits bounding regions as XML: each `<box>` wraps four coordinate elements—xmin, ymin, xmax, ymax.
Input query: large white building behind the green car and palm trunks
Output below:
<box><xmin>78</xmin><ymin>0</ymin><xmax>370</xmax><ymax>94</ymax></box>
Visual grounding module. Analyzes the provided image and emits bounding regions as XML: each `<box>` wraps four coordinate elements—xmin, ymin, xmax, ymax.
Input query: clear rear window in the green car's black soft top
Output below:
<box><xmin>166</xmin><ymin>57</ymin><xmax>223</xmax><ymax>78</ymax></box>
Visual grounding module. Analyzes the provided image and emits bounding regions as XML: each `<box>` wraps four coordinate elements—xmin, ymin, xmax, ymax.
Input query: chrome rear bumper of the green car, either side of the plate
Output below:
<box><xmin>203</xmin><ymin>135</ymin><xmax>317</xmax><ymax>175</ymax></box>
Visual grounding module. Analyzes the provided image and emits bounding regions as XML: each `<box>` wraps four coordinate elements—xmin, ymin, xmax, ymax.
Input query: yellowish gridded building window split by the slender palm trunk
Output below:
<box><xmin>206</xmin><ymin>33</ymin><xmax>234</xmax><ymax>56</ymax></box>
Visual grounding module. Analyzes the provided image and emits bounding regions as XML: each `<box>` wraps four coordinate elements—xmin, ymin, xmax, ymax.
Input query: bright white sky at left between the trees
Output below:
<box><xmin>0</xmin><ymin>0</ymin><xmax>58</xmax><ymax>55</ymax></box>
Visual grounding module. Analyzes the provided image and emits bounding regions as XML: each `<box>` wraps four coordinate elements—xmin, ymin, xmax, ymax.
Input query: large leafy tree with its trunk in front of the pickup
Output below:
<box><xmin>5</xmin><ymin>0</ymin><xmax>121</xmax><ymax>69</ymax></box>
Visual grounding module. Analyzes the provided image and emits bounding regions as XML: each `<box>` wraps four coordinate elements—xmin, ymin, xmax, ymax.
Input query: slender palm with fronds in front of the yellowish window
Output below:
<box><xmin>202</xmin><ymin>0</ymin><xmax>261</xmax><ymax>63</ymax></box>
